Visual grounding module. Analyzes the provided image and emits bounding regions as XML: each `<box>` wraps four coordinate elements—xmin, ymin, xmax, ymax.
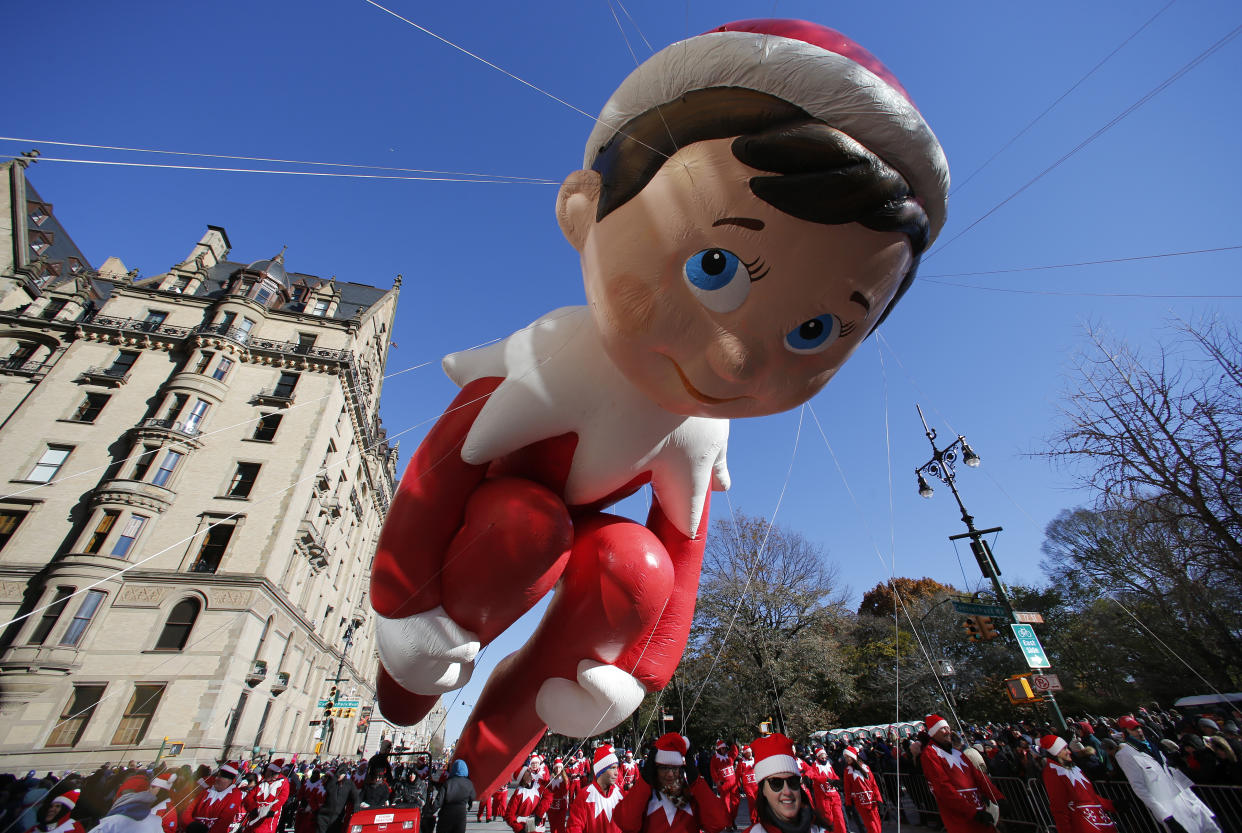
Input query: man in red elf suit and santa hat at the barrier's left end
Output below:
<box><xmin>919</xmin><ymin>714</ymin><xmax>1001</xmax><ymax>833</ymax></box>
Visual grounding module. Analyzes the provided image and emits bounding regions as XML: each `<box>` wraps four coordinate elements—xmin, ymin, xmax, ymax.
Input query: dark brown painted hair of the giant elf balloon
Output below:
<box><xmin>591</xmin><ymin>87</ymin><xmax>930</xmax><ymax>326</ymax></box>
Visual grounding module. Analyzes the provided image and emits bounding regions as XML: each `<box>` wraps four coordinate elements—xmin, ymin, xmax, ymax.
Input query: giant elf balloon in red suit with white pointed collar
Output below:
<box><xmin>371</xmin><ymin>20</ymin><xmax>949</xmax><ymax>795</ymax></box>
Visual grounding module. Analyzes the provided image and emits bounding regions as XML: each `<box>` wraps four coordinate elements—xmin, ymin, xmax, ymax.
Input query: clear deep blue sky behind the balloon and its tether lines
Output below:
<box><xmin>12</xmin><ymin>0</ymin><xmax>1242</xmax><ymax>736</ymax></box>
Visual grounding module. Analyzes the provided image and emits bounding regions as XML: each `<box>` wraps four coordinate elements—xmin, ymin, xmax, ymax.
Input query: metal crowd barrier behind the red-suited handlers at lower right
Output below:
<box><xmin>877</xmin><ymin>772</ymin><xmax>1242</xmax><ymax>833</ymax></box>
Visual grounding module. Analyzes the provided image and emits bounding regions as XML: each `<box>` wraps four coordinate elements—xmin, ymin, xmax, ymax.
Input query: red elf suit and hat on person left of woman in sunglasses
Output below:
<box><xmin>614</xmin><ymin>732</ymin><xmax>728</xmax><ymax>833</ymax></box>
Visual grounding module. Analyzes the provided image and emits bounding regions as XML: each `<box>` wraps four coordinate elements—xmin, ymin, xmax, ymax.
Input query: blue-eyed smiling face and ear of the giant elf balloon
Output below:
<box><xmin>559</xmin><ymin>139</ymin><xmax>912</xmax><ymax>418</ymax></box>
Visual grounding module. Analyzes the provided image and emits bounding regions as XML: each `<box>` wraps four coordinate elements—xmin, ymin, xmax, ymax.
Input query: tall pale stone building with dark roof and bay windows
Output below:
<box><xmin>0</xmin><ymin>160</ymin><xmax>443</xmax><ymax>771</ymax></box>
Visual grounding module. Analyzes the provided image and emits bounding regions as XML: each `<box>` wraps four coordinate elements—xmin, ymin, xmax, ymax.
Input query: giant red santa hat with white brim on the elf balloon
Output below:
<box><xmin>582</xmin><ymin>20</ymin><xmax>949</xmax><ymax>243</ymax></box>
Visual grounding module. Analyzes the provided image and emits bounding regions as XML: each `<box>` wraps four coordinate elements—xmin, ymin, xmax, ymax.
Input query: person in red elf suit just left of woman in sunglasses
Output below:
<box><xmin>614</xmin><ymin>732</ymin><xmax>729</xmax><ymax>833</ymax></box>
